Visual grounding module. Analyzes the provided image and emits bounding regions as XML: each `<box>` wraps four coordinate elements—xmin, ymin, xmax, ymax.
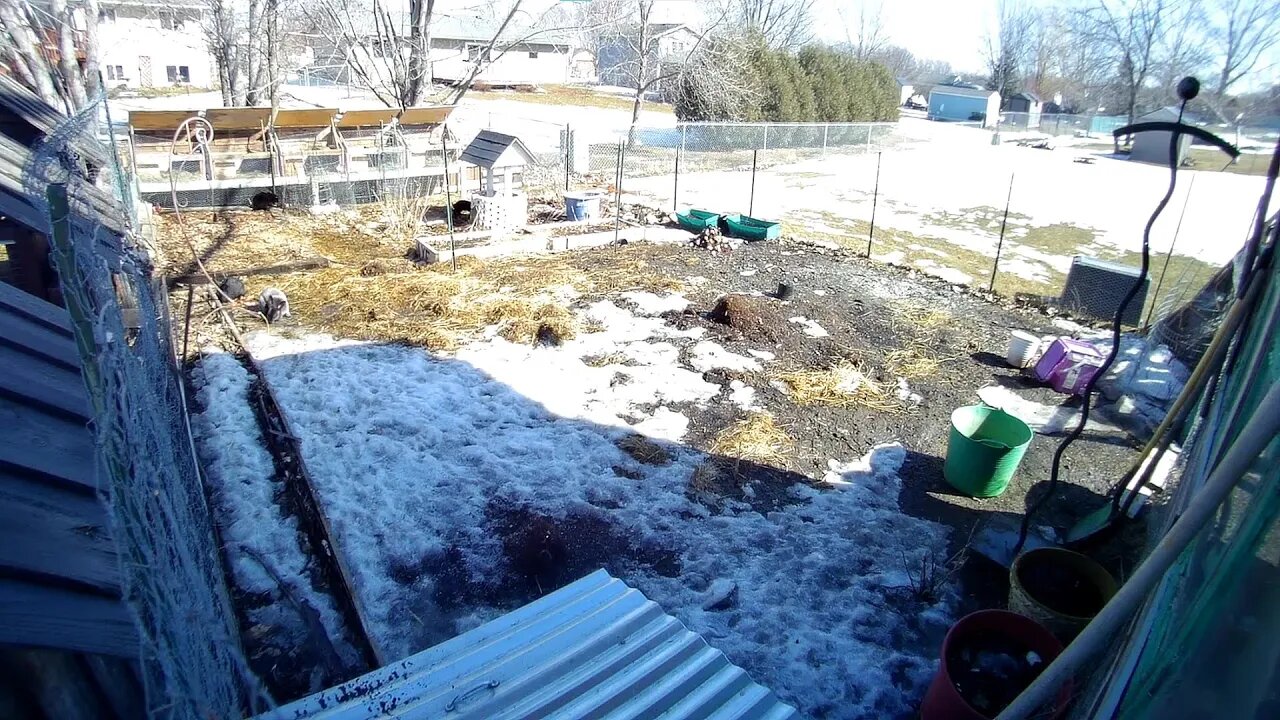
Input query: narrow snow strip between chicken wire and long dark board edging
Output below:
<box><xmin>191</xmin><ymin>348</ymin><xmax>358</xmax><ymax>662</ymax></box>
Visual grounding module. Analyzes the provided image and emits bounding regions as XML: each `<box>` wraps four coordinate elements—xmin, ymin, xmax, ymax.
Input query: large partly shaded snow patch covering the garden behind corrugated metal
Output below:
<box><xmin>240</xmin><ymin>293</ymin><xmax>957</xmax><ymax>719</ymax></box>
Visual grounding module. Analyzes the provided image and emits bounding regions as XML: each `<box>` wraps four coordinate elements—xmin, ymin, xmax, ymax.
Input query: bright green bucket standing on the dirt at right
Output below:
<box><xmin>942</xmin><ymin>405</ymin><xmax>1034</xmax><ymax>497</ymax></box>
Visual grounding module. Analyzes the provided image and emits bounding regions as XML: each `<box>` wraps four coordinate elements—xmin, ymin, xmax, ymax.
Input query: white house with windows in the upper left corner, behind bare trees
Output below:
<box><xmin>97</xmin><ymin>0</ymin><xmax>218</xmax><ymax>87</ymax></box>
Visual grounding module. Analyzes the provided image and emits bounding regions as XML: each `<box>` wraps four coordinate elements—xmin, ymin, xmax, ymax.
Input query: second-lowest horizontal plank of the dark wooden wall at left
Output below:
<box><xmin>0</xmin><ymin>470</ymin><xmax>120</xmax><ymax>597</ymax></box>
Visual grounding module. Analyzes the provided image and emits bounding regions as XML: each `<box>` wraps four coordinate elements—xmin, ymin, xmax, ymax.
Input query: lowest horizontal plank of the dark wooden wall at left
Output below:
<box><xmin>0</xmin><ymin>578</ymin><xmax>140</xmax><ymax>657</ymax></box>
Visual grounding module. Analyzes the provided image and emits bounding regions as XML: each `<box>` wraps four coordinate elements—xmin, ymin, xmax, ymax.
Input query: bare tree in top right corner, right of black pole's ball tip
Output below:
<box><xmin>1208</xmin><ymin>0</ymin><xmax>1280</xmax><ymax>101</ymax></box>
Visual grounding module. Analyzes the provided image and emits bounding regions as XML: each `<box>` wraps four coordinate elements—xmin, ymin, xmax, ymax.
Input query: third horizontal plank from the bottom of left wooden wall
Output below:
<box><xmin>0</xmin><ymin>396</ymin><xmax>96</xmax><ymax>489</ymax></box>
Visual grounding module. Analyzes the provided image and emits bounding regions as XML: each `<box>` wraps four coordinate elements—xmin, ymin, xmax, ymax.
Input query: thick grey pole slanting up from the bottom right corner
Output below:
<box><xmin>996</xmin><ymin>383</ymin><xmax>1280</xmax><ymax>720</ymax></box>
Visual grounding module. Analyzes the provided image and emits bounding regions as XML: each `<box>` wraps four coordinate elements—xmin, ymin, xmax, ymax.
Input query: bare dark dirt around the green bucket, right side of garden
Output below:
<box><xmin>603</xmin><ymin>242</ymin><xmax>1140</xmax><ymax>609</ymax></box>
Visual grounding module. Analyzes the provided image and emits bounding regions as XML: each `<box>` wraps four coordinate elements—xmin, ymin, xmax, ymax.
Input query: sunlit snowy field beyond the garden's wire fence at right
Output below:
<box><xmin>625</xmin><ymin>118</ymin><xmax>1280</xmax><ymax>282</ymax></box>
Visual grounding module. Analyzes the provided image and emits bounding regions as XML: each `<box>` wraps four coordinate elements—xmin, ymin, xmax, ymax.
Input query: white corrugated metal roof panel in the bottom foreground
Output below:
<box><xmin>261</xmin><ymin>570</ymin><xmax>799</xmax><ymax>720</ymax></box>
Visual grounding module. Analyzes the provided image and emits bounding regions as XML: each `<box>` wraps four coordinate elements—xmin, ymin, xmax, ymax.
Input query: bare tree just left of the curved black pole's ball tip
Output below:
<box><xmin>1076</xmin><ymin>0</ymin><xmax>1169</xmax><ymax>123</ymax></box>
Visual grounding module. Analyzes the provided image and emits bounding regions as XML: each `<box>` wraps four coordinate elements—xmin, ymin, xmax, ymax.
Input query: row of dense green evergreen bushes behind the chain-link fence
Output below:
<box><xmin>676</xmin><ymin>40</ymin><xmax>899</xmax><ymax>123</ymax></box>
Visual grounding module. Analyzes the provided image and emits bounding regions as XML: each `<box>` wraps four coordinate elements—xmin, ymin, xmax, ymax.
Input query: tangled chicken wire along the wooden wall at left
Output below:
<box><xmin>24</xmin><ymin>100</ymin><xmax>270</xmax><ymax>719</ymax></box>
